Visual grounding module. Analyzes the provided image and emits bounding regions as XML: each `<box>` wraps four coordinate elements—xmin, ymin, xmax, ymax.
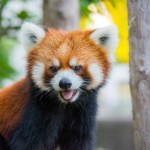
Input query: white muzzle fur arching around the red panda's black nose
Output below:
<box><xmin>51</xmin><ymin>69</ymin><xmax>83</xmax><ymax>91</ymax></box>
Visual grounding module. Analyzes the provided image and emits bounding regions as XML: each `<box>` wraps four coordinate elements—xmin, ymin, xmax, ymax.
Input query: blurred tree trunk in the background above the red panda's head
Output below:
<box><xmin>43</xmin><ymin>0</ymin><xmax>80</xmax><ymax>31</ymax></box>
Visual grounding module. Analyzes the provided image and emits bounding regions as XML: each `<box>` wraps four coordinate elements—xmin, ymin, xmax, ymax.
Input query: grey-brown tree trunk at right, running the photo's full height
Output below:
<box><xmin>128</xmin><ymin>0</ymin><xmax>150</xmax><ymax>150</ymax></box>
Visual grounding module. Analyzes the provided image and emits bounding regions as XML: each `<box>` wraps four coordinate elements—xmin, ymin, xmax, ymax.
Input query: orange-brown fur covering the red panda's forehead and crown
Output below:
<box><xmin>28</xmin><ymin>29</ymin><xmax>110</xmax><ymax>83</ymax></box>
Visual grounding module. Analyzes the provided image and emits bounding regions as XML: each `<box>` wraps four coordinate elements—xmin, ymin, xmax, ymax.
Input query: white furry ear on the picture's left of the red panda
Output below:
<box><xmin>20</xmin><ymin>22</ymin><xmax>45</xmax><ymax>49</ymax></box>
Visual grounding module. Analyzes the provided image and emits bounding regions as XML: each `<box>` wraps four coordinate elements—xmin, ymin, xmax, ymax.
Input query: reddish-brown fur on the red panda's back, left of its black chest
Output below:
<box><xmin>0</xmin><ymin>79</ymin><xmax>29</xmax><ymax>139</ymax></box>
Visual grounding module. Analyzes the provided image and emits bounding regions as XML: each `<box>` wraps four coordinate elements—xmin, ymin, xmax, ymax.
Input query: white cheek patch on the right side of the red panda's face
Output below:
<box><xmin>88</xmin><ymin>63</ymin><xmax>104</xmax><ymax>89</ymax></box>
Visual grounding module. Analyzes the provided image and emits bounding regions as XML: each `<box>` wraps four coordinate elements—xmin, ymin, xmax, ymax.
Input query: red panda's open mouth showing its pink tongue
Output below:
<box><xmin>60</xmin><ymin>90</ymin><xmax>77</xmax><ymax>102</ymax></box>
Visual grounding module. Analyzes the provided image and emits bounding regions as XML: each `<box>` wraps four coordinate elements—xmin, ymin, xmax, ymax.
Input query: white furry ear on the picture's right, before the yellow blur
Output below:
<box><xmin>90</xmin><ymin>24</ymin><xmax>119</xmax><ymax>59</ymax></box>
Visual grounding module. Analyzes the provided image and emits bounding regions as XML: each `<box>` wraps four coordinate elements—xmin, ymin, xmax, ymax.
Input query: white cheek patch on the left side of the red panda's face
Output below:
<box><xmin>32</xmin><ymin>61</ymin><xmax>50</xmax><ymax>91</ymax></box>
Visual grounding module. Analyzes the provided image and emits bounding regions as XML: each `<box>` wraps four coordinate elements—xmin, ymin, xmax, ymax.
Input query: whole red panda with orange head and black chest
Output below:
<box><xmin>0</xmin><ymin>23</ymin><xmax>118</xmax><ymax>150</ymax></box>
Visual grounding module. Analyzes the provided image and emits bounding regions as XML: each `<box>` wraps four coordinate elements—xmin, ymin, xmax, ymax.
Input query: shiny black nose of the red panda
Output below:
<box><xmin>59</xmin><ymin>78</ymin><xmax>72</xmax><ymax>90</ymax></box>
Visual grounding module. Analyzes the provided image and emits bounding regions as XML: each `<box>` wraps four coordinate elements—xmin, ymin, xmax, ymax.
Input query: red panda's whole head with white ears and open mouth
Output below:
<box><xmin>22</xmin><ymin>23</ymin><xmax>118</xmax><ymax>102</ymax></box>
